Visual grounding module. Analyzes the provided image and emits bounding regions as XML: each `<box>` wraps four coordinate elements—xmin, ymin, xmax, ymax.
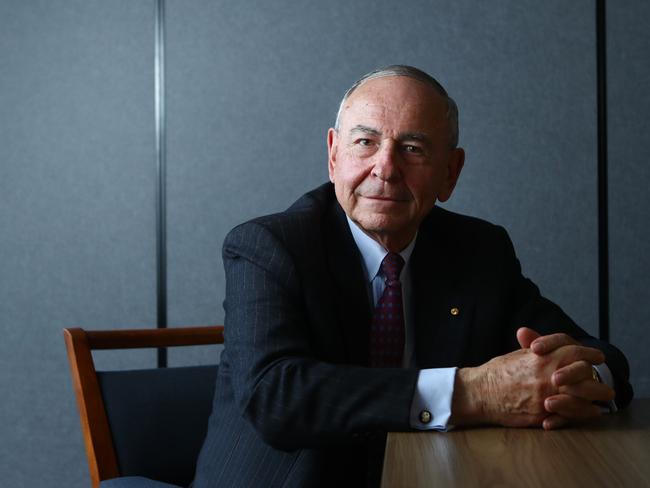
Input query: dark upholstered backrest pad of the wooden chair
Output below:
<box><xmin>97</xmin><ymin>365</ymin><xmax>218</xmax><ymax>486</ymax></box>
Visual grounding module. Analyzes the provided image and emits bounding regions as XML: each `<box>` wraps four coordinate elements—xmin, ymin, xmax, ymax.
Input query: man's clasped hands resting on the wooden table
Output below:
<box><xmin>450</xmin><ymin>327</ymin><xmax>614</xmax><ymax>430</ymax></box>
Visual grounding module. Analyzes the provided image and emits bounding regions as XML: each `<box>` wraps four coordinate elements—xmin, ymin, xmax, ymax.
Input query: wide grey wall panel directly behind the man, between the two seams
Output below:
<box><xmin>167</xmin><ymin>0</ymin><xmax>598</xmax><ymax>364</ymax></box>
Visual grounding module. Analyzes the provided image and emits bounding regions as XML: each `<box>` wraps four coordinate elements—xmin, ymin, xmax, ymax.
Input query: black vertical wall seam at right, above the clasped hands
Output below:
<box><xmin>596</xmin><ymin>0</ymin><xmax>609</xmax><ymax>341</ymax></box>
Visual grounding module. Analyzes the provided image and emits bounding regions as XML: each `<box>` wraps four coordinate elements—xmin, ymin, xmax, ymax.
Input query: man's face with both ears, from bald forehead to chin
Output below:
<box><xmin>327</xmin><ymin>76</ymin><xmax>464</xmax><ymax>252</ymax></box>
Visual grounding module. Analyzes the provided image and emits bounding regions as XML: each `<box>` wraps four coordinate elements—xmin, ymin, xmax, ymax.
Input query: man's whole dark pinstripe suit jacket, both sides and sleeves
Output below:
<box><xmin>194</xmin><ymin>184</ymin><xmax>631</xmax><ymax>488</ymax></box>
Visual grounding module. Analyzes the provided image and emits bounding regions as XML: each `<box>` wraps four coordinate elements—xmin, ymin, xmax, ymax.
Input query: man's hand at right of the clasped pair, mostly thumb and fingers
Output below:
<box><xmin>517</xmin><ymin>327</ymin><xmax>615</xmax><ymax>430</ymax></box>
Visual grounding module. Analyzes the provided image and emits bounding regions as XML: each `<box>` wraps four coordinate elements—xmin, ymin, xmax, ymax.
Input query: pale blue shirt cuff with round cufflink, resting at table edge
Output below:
<box><xmin>410</xmin><ymin>368</ymin><xmax>458</xmax><ymax>431</ymax></box>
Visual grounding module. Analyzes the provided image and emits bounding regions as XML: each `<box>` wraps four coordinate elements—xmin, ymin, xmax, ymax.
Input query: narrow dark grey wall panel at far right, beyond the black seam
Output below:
<box><xmin>607</xmin><ymin>0</ymin><xmax>650</xmax><ymax>397</ymax></box>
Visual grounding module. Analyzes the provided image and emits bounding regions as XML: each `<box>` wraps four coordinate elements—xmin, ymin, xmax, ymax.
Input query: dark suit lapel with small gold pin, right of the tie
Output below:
<box><xmin>411</xmin><ymin>207</ymin><xmax>474</xmax><ymax>368</ymax></box>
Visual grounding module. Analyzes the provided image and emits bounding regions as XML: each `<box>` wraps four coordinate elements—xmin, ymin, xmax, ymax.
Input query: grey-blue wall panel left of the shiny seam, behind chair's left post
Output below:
<box><xmin>0</xmin><ymin>0</ymin><xmax>155</xmax><ymax>488</ymax></box>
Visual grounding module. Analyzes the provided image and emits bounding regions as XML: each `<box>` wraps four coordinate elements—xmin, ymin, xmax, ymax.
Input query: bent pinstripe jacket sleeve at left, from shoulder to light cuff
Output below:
<box><xmin>223</xmin><ymin>223</ymin><xmax>417</xmax><ymax>450</ymax></box>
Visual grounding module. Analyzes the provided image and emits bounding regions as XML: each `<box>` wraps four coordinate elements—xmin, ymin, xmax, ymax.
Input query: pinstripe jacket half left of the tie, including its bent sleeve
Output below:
<box><xmin>194</xmin><ymin>184</ymin><xmax>417</xmax><ymax>488</ymax></box>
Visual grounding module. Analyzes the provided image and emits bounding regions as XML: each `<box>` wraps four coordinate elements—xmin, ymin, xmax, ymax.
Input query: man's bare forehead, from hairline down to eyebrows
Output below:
<box><xmin>341</xmin><ymin>76</ymin><xmax>447</xmax><ymax>132</ymax></box>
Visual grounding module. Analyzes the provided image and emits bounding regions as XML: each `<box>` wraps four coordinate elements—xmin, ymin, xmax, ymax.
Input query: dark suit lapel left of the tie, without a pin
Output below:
<box><xmin>325</xmin><ymin>201</ymin><xmax>372</xmax><ymax>365</ymax></box>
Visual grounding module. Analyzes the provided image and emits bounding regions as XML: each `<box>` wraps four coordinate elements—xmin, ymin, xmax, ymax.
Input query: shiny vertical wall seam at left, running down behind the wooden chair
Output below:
<box><xmin>154</xmin><ymin>0</ymin><xmax>167</xmax><ymax>368</ymax></box>
